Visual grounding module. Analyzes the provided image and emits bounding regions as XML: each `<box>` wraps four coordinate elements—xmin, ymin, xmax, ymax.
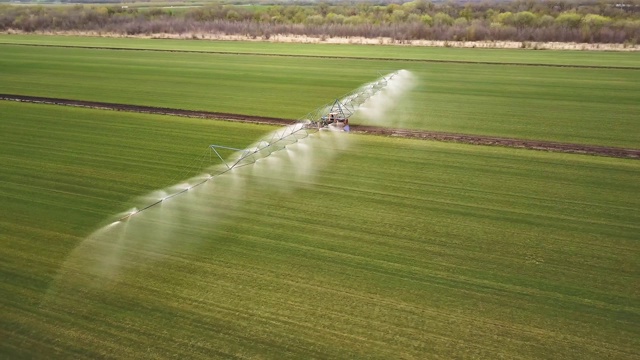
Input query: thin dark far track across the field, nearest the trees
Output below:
<box><xmin>5</xmin><ymin>42</ymin><xmax>640</xmax><ymax>70</ymax></box>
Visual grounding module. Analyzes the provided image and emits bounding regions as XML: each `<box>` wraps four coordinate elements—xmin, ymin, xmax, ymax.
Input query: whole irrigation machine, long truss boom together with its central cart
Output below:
<box><xmin>116</xmin><ymin>71</ymin><xmax>399</xmax><ymax>223</ymax></box>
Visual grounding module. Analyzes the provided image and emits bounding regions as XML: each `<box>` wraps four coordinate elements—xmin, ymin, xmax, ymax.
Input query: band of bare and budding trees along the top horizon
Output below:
<box><xmin>0</xmin><ymin>0</ymin><xmax>640</xmax><ymax>44</ymax></box>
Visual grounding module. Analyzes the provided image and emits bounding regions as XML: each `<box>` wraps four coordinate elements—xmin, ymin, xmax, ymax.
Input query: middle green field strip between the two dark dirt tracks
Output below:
<box><xmin>0</xmin><ymin>43</ymin><xmax>640</xmax><ymax>148</ymax></box>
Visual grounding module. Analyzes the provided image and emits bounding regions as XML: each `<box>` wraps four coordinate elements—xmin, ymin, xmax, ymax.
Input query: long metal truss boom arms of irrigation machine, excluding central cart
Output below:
<box><xmin>114</xmin><ymin>71</ymin><xmax>399</xmax><ymax>224</ymax></box>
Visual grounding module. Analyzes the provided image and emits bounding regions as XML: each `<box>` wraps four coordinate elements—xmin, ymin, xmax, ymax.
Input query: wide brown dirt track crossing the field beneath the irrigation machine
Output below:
<box><xmin>0</xmin><ymin>94</ymin><xmax>640</xmax><ymax>159</ymax></box>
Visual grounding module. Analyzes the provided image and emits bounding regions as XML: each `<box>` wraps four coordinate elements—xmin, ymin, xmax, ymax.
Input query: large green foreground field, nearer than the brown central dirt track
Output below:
<box><xmin>0</xmin><ymin>102</ymin><xmax>640</xmax><ymax>359</ymax></box>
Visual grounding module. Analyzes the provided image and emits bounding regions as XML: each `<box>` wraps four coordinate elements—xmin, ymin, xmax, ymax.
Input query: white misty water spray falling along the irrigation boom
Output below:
<box><xmin>43</xmin><ymin>71</ymin><xmax>418</xmax><ymax>304</ymax></box>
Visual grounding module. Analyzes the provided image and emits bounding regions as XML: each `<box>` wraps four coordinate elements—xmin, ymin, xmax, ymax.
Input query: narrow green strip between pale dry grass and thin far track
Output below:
<box><xmin>0</xmin><ymin>35</ymin><xmax>640</xmax><ymax>68</ymax></box>
